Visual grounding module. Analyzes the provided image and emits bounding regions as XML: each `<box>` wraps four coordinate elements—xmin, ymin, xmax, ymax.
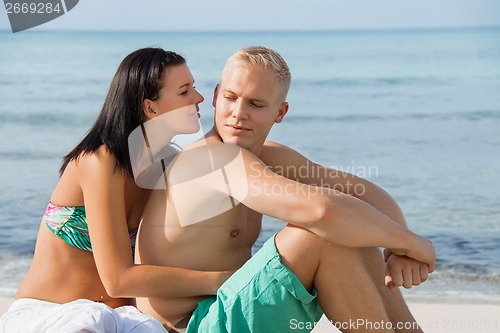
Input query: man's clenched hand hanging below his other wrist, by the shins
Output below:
<box><xmin>384</xmin><ymin>249</ymin><xmax>431</xmax><ymax>290</ymax></box>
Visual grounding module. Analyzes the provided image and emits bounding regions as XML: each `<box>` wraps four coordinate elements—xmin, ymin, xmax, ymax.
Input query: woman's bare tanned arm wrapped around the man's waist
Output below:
<box><xmin>77</xmin><ymin>149</ymin><xmax>230</xmax><ymax>298</ymax></box>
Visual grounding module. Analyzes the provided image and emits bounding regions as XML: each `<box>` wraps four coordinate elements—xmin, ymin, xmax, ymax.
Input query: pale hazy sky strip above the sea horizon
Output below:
<box><xmin>0</xmin><ymin>0</ymin><xmax>500</xmax><ymax>31</ymax></box>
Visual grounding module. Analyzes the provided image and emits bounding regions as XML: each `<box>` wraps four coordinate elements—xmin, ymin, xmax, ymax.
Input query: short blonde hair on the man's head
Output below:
<box><xmin>221</xmin><ymin>46</ymin><xmax>292</xmax><ymax>103</ymax></box>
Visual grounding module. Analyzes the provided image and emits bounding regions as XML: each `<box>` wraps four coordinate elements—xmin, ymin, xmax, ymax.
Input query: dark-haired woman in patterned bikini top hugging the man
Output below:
<box><xmin>0</xmin><ymin>48</ymin><xmax>230</xmax><ymax>332</ymax></box>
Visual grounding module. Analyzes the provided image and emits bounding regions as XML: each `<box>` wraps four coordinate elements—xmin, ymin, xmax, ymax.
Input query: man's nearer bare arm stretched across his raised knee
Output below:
<box><xmin>205</xmin><ymin>144</ymin><xmax>435</xmax><ymax>270</ymax></box>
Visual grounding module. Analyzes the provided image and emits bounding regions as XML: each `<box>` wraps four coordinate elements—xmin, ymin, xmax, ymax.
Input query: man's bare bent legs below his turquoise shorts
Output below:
<box><xmin>276</xmin><ymin>225</ymin><xmax>422</xmax><ymax>333</ymax></box>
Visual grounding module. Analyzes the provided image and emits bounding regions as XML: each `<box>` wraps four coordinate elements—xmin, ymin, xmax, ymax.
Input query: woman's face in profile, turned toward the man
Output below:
<box><xmin>150</xmin><ymin>64</ymin><xmax>203</xmax><ymax>134</ymax></box>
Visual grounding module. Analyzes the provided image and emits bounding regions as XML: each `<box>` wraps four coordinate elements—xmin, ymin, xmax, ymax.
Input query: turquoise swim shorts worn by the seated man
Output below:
<box><xmin>187</xmin><ymin>236</ymin><xmax>323</xmax><ymax>333</ymax></box>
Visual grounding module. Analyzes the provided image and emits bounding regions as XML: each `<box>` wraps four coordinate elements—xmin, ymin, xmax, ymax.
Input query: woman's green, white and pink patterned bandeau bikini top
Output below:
<box><xmin>42</xmin><ymin>202</ymin><xmax>137</xmax><ymax>252</ymax></box>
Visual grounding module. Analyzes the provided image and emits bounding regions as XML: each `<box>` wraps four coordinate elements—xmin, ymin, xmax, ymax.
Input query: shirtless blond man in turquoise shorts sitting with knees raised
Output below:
<box><xmin>136</xmin><ymin>47</ymin><xmax>435</xmax><ymax>332</ymax></box>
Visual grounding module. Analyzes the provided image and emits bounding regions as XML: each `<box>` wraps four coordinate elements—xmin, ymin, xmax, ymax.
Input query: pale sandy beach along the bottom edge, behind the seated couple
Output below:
<box><xmin>0</xmin><ymin>297</ymin><xmax>500</xmax><ymax>333</ymax></box>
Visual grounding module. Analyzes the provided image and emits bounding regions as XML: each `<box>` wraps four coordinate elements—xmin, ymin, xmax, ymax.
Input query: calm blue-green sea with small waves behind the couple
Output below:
<box><xmin>0</xmin><ymin>27</ymin><xmax>500</xmax><ymax>304</ymax></box>
